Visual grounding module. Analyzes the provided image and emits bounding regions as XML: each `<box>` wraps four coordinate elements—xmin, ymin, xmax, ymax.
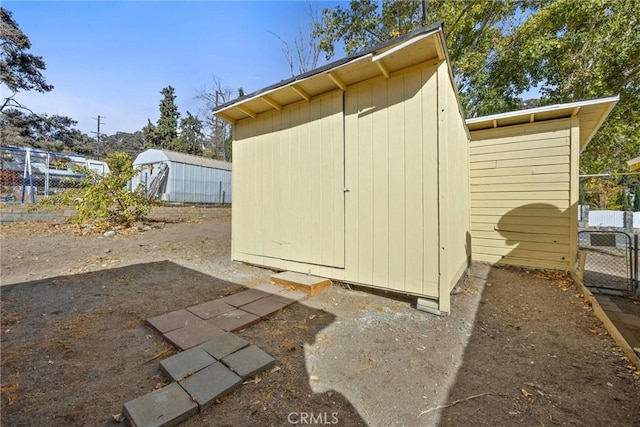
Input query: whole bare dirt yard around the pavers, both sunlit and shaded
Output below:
<box><xmin>0</xmin><ymin>212</ymin><xmax>640</xmax><ymax>426</ymax></box>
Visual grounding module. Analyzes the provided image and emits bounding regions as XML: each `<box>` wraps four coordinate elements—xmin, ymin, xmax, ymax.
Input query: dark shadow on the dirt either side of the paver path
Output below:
<box><xmin>0</xmin><ymin>261</ymin><xmax>364</xmax><ymax>426</ymax></box>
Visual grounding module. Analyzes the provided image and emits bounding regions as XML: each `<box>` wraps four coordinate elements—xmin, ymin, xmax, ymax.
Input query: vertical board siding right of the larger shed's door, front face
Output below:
<box><xmin>345</xmin><ymin>65</ymin><xmax>439</xmax><ymax>297</ymax></box>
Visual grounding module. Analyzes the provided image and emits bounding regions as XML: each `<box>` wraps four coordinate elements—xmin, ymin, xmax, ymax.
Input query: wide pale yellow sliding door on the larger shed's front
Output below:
<box><xmin>233</xmin><ymin>91</ymin><xmax>344</xmax><ymax>267</ymax></box>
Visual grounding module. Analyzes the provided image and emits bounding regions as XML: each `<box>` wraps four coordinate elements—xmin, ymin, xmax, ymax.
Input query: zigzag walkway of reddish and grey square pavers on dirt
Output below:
<box><xmin>123</xmin><ymin>283</ymin><xmax>316</xmax><ymax>427</ymax></box>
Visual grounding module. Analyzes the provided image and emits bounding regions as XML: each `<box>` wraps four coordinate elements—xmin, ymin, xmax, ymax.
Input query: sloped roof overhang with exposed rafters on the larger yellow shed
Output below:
<box><xmin>213</xmin><ymin>23</ymin><xmax>448</xmax><ymax>124</ymax></box>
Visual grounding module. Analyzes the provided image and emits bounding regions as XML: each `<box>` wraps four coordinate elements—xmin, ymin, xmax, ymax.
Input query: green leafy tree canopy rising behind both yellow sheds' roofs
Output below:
<box><xmin>313</xmin><ymin>0</ymin><xmax>640</xmax><ymax>174</ymax></box>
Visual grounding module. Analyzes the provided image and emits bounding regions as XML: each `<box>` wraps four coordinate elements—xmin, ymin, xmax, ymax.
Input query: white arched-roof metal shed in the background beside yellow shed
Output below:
<box><xmin>132</xmin><ymin>149</ymin><xmax>232</xmax><ymax>203</ymax></box>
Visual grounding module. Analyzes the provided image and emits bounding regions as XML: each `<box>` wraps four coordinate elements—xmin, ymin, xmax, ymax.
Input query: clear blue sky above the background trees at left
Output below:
<box><xmin>2</xmin><ymin>0</ymin><xmax>348</xmax><ymax>135</ymax></box>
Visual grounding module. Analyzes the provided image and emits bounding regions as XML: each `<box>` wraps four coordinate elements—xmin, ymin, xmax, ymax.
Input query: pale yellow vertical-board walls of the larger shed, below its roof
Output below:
<box><xmin>233</xmin><ymin>62</ymin><xmax>469</xmax><ymax>298</ymax></box>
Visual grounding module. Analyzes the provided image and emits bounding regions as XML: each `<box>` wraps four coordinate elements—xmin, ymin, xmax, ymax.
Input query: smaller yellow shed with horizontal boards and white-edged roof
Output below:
<box><xmin>466</xmin><ymin>96</ymin><xmax>619</xmax><ymax>271</ymax></box>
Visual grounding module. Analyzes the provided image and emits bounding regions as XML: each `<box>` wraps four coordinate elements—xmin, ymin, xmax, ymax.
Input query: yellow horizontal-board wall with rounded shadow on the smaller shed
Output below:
<box><xmin>469</xmin><ymin>119</ymin><xmax>577</xmax><ymax>268</ymax></box>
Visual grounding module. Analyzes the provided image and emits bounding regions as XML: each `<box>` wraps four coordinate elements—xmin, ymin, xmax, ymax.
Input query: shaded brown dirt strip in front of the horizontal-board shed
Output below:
<box><xmin>436</xmin><ymin>266</ymin><xmax>640</xmax><ymax>426</ymax></box>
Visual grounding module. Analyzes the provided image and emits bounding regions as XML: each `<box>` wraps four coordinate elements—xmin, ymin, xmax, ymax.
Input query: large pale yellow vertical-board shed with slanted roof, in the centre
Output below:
<box><xmin>215</xmin><ymin>24</ymin><xmax>470</xmax><ymax>318</ymax></box>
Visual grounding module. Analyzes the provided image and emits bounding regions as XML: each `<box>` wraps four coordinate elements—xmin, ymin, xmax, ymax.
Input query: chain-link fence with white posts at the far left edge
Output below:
<box><xmin>0</xmin><ymin>147</ymin><xmax>109</xmax><ymax>203</ymax></box>
